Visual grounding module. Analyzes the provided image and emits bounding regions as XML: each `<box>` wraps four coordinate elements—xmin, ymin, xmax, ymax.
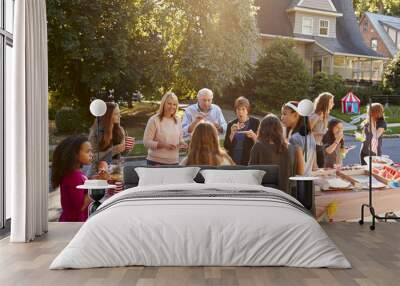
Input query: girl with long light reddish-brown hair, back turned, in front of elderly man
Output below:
<box><xmin>180</xmin><ymin>122</ymin><xmax>235</xmax><ymax>166</ymax></box>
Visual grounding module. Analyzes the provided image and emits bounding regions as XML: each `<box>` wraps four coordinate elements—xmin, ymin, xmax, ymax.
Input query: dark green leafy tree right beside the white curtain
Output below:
<box><xmin>47</xmin><ymin>0</ymin><xmax>139</xmax><ymax>110</ymax></box>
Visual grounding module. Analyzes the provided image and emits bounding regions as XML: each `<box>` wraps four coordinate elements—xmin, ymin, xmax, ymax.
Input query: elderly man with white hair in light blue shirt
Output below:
<box><xmin>182</xmin><ymin>88</ymin><xmax>227</xmax><ymax>137</ymax></box>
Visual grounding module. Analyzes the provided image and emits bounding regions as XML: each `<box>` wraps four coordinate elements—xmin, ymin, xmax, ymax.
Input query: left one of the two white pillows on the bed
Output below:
<box><xmin>135</xmin><ymin>167</ymin><xmax>200</xmax><ymax>186</ymax></box>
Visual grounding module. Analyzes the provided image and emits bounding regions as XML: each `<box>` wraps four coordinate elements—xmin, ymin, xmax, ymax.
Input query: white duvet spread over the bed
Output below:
<box><xmin>50</xmin><ymin>184</ymin><xmax>351</xmax><ymax>269</ymax></box>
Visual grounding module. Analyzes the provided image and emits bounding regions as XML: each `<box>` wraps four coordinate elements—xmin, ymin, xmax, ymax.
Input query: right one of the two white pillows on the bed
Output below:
<box><xmin>200</xmin><ymin>170</ymin><xmax>265</xmax><ymax>185</ymax></box>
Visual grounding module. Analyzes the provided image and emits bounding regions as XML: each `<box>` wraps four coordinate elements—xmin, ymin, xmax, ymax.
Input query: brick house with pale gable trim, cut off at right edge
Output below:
<box><xmin>360</xmin><ymin>12</ymin><xmax>400</xmax><ymax>58</ymax></box>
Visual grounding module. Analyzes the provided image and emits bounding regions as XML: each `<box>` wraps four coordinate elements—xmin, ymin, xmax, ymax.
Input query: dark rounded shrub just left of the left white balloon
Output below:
<box><xmin>55</xmin><ymin>108</ymin><xmax>89</xmax><ymax>134</ymax></box>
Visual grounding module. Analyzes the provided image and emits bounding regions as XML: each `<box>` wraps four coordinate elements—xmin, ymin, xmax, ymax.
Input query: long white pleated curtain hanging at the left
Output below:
<box><xmin>6</xmin><ymin>0</ymin><xmax>49</xmax><ymax>242</ymax></box>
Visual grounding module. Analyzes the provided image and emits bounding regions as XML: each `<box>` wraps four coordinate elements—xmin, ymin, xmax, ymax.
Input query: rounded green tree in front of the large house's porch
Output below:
<box><xmin>249</xmin><ymin>39</ymin><xmax>310</xmax><ymax>107</ymax></box>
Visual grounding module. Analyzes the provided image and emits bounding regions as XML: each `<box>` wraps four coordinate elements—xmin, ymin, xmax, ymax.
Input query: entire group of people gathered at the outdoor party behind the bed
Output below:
<box><xmin>51</xmin><ymin>88</ymin><xmax>386</xmax><ymax>221</ymax></box>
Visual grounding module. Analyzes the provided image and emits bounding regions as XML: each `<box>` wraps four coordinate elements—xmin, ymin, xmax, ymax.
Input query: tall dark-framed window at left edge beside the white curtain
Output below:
<box><xmin>0</xmin><ymin>0</ymin><xmax>14</xmax><ymax>229</ymax></box>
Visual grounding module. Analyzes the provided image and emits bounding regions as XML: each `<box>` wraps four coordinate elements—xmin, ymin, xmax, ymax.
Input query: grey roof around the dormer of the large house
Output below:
<box><xmin>256</xmin><ymin>0</ymin><xmax>383</xmax><ymax>58</ymax></box>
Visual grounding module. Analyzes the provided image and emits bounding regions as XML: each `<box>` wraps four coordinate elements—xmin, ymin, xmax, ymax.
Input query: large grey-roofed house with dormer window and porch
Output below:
<box><xmin>256</xmin><ymin>0</ymin><xmax>386</xmax><ymax>82</ymax></box>
